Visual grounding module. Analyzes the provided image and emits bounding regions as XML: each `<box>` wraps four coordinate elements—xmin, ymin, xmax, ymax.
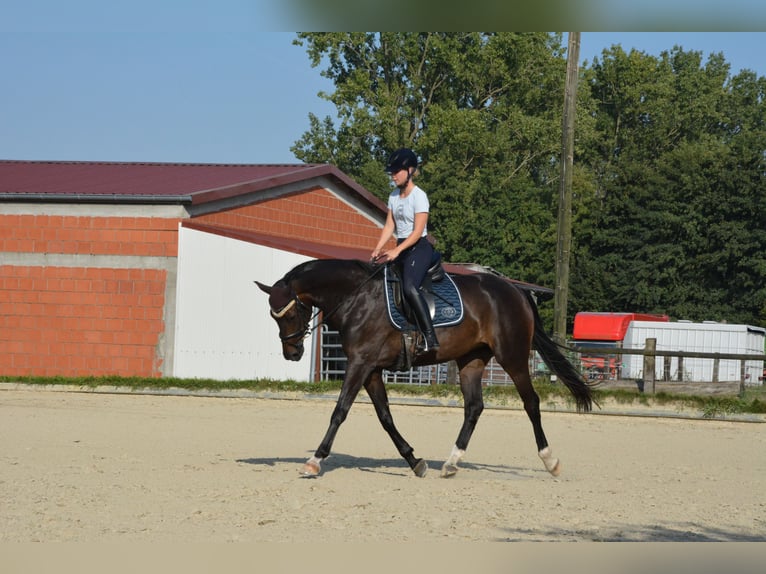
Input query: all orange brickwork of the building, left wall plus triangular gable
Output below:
<box><xmin>0</xmin><ymin>188</ymin><xmax>388</xmax><ymax>377</ymax></box>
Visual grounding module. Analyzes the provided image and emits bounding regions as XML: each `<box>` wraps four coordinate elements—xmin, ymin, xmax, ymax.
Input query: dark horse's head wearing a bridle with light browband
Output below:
<box><xmin>255</xmin><ymin>280</ymin><xmax>311</xmax><ymax>361</ymax></box>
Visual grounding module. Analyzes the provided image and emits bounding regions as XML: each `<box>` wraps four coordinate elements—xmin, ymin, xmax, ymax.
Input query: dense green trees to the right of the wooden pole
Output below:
<box><xmin>573</xmin><ymin>47</ymin><xmax>766</xmax><ymax>323</ymax></box>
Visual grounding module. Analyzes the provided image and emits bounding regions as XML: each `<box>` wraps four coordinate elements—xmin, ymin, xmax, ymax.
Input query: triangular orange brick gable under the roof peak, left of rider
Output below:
<box><xmin>194</xmin><ymin>188</ymin><xmax>388</xmax><ymax>250</ymax></box>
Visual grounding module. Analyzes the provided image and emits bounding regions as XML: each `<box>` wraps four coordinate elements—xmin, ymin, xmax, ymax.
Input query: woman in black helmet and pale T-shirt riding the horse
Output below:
<box><xmin>372</xmin><ymin>148</ymin><xmax>439</xmax><ymax>353</ymax></box>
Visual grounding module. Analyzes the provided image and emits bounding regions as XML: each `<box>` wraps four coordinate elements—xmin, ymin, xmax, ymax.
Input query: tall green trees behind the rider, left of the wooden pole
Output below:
<box><xmin>293</xmin><ymin>33</ymin><xmax>566</xmax><ymax>302</ymax></box>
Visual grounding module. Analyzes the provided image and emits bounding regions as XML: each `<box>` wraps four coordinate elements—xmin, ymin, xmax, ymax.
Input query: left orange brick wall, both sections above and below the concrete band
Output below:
<box><xmin>0</xmin><ymin>215</ymin><xmax>178</xmax><ymax>376</ymax></box>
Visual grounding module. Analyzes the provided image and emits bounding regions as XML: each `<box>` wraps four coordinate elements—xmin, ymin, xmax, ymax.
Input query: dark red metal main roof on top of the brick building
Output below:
<box><xmin>0</xmin><ymin>160</ymin><xmax>385</xmax><ymax>210</ymax></box>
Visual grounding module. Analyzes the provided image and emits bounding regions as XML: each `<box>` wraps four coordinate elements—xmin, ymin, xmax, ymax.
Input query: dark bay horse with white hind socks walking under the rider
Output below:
<box><xmin>256</xmin><ymin>259</ymin><xmax>593</xmax><ymax>477</ymax></box>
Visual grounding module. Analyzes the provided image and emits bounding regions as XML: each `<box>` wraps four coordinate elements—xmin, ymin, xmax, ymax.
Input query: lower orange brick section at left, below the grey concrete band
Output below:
<box><xmin>0</xmin><ymin>266</ymin><xmax>166</xmax><ymax>376</ymax></box>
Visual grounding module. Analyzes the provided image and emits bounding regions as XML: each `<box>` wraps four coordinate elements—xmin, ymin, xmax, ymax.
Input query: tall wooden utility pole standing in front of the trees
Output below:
<box><xmin>553</xmin><ymin>32</ymin><xmax>580</xmax><ymax>344</ymax></box>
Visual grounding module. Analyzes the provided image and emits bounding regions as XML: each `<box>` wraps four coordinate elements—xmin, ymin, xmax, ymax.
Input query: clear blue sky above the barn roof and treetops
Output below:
<box><xmin>0</xmin><ymin>23</ymin><xmax>766</xmax><ymax>163</ymax></box>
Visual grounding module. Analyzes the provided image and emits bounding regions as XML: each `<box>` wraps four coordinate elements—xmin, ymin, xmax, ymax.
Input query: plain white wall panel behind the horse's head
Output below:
<box><xmin>173</xmin><ymin>227</ymin><xmax>312</xmax><ymax>381</ymax></box>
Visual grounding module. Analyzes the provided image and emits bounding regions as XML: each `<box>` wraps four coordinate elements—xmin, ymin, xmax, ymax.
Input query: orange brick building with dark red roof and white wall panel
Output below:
<box><xmin>0</xmin><ymin>161</ymin><xmax>552</xmax><ymax>380</ymax></box>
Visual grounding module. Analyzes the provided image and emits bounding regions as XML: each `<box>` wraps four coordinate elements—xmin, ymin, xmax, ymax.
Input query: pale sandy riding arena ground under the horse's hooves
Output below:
<box><xmin>0</xmin><ymin>390</ymin><xmax>766</xmax><ymax>543</ymax></box>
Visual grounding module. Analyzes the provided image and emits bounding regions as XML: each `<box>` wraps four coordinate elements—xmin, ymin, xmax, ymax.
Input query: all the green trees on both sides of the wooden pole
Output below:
<box><xmin>293</xmin><ymin>36</ymin><xmax>766</xmax><ymax>325</ymax></box>
